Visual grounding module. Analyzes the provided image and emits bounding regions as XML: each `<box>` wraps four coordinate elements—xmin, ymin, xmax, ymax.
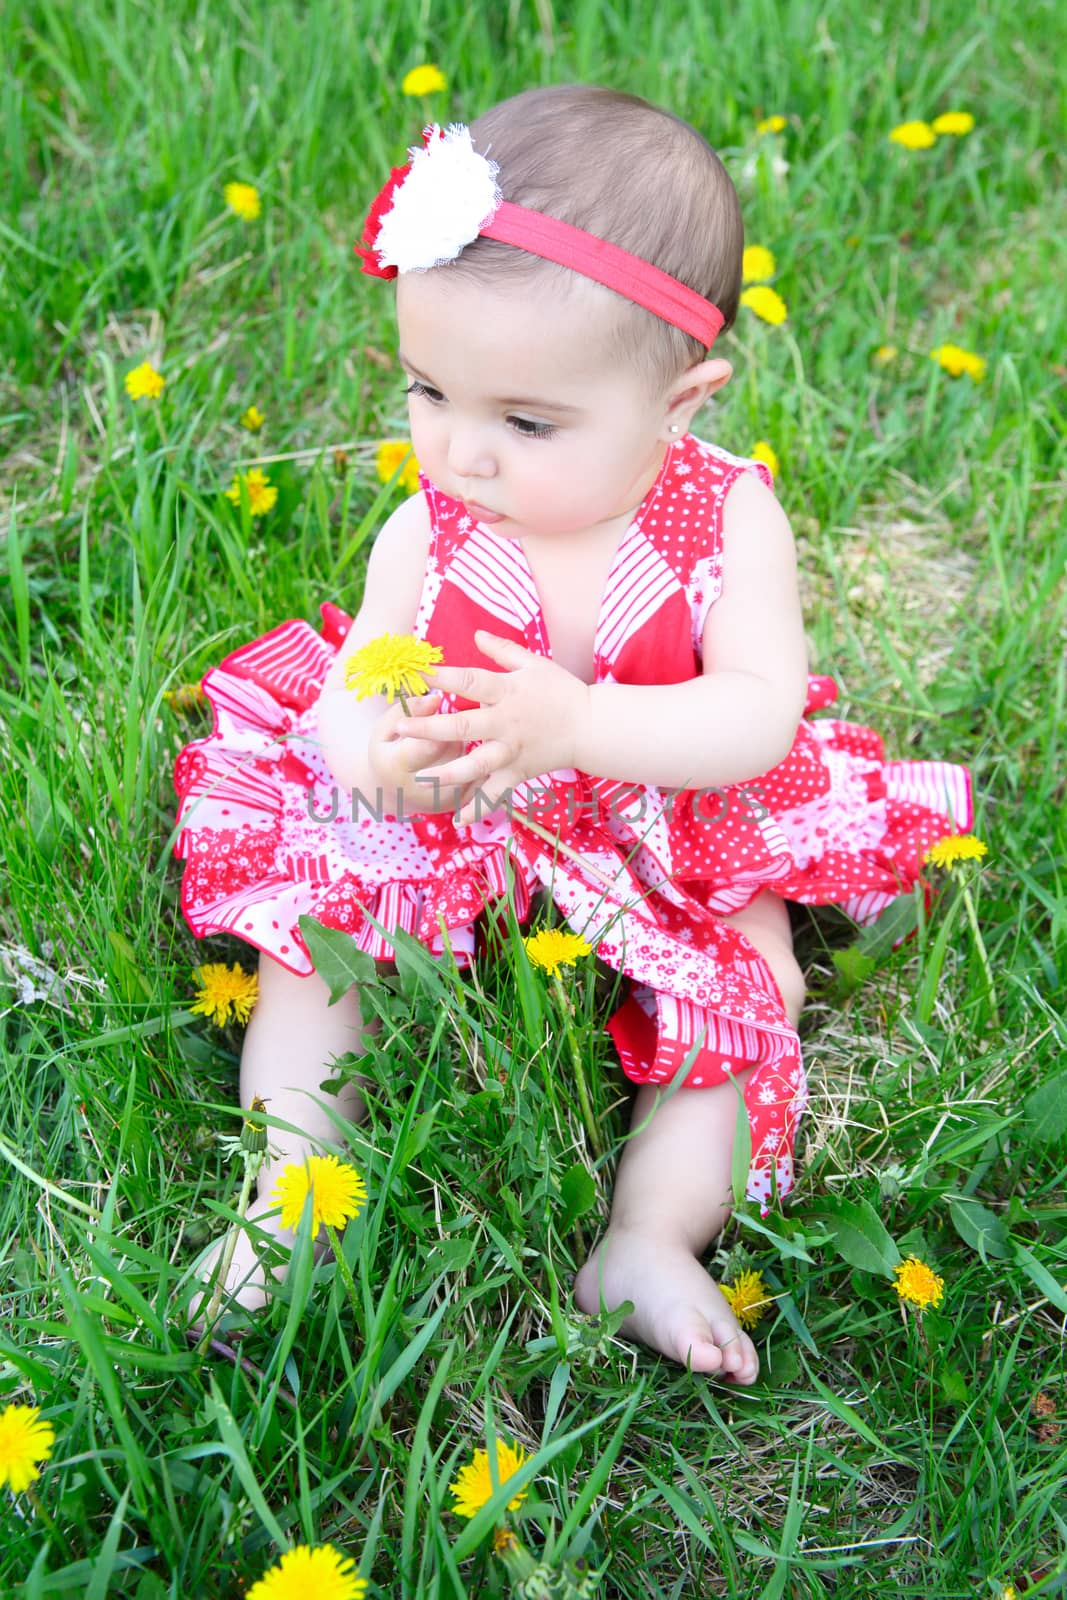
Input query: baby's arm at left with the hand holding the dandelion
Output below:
<box><xmin>318</xmin><ymin>493</ymin><xmax>462</xmax><ymax>814</ymax></box>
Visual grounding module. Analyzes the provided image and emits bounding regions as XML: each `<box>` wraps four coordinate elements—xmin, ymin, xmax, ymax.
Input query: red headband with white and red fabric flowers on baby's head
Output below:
<box><xmin>355</xmin><ymin>125</ymin><xmax>723</xmax><ymax>349</ymax></box>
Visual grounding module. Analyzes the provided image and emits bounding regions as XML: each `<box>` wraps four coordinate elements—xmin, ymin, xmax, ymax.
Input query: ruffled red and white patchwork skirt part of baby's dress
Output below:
<box><xmin>174</xmin><ymin>605</ymin><xmax>971</xmax><ymax>1205</ymax></box>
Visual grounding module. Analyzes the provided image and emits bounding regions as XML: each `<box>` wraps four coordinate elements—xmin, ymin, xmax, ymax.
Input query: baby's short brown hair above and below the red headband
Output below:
<box><xmin>442</xmin><ymin>83</ymin><xmax>744</xmax><ymax>394</ymax></box>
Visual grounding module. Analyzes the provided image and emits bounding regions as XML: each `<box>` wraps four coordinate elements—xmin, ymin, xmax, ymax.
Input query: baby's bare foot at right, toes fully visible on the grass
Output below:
<box><xmin>574</xmin><ymin>1229</ymin><xmax>760</xmax><ymax>1384</ymax></box>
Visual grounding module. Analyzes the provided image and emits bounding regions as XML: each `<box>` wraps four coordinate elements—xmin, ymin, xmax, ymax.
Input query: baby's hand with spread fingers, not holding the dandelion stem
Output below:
<box><xmin>397</xmin><ymin>630</ymin><xmax>589</xmax><ymax>822</ymax></box>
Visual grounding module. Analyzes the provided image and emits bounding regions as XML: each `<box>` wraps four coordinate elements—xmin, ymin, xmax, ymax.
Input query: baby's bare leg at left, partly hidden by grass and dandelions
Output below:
<box><xmin>197</xmin><ymin>955</ymin><xmax>366</xmax><ymax>1310</ymax></box>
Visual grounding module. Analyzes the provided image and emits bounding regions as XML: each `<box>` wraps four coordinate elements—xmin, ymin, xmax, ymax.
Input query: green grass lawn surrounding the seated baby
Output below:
<box><xmin>0</xmin><ymin>0</ymin><xmax>1067</xmax><ymax>1600</ymax></box>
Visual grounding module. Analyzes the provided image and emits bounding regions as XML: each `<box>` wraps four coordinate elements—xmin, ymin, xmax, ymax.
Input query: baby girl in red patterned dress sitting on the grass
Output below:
<box><xmin>176</xmin><ymin>85</ymin><xmax>971</xmax><ymax>1384</ymax></box>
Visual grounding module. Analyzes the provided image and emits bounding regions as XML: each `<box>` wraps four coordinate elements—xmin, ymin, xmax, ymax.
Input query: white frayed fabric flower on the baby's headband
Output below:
<box><xmin>374</xmin><ymin>123</ymin><xmax>504</xmax><ymax>272</ymax></box>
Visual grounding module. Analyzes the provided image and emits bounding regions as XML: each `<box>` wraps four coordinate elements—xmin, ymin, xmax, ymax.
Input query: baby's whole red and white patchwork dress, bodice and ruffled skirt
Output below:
<box><xmin>174</xmin><ymin>435</ymin><xmax>973</xmax><ymax>1203</ymax></box>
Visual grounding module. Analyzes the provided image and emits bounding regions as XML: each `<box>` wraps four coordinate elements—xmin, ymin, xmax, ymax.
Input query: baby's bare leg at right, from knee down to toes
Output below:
<box><xmin>574</xmin><ymin>893</ymin><xmax>803</xmax><ymax>1384</ymax></box>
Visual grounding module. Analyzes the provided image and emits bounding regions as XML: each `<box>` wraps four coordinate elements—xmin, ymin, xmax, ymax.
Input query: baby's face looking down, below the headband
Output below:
<box><xmin>397</xmin><ymin>267</ymin><xmax>665</xmax><ymax>538</ymax></box>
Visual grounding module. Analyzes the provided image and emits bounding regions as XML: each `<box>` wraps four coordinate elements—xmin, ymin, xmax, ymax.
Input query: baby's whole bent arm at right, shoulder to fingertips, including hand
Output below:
<box><xmin>400</xmin><ymin>474</ymin><xmax>808</xmax><ymax>800</ymax></box>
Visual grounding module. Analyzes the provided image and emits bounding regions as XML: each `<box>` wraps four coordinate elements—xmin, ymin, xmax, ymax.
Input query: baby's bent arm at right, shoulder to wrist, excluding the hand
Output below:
<box><xmin>573</xmin><ymin>472</ymin><xmax>808</xmax><ymax>789</ymax></box>
